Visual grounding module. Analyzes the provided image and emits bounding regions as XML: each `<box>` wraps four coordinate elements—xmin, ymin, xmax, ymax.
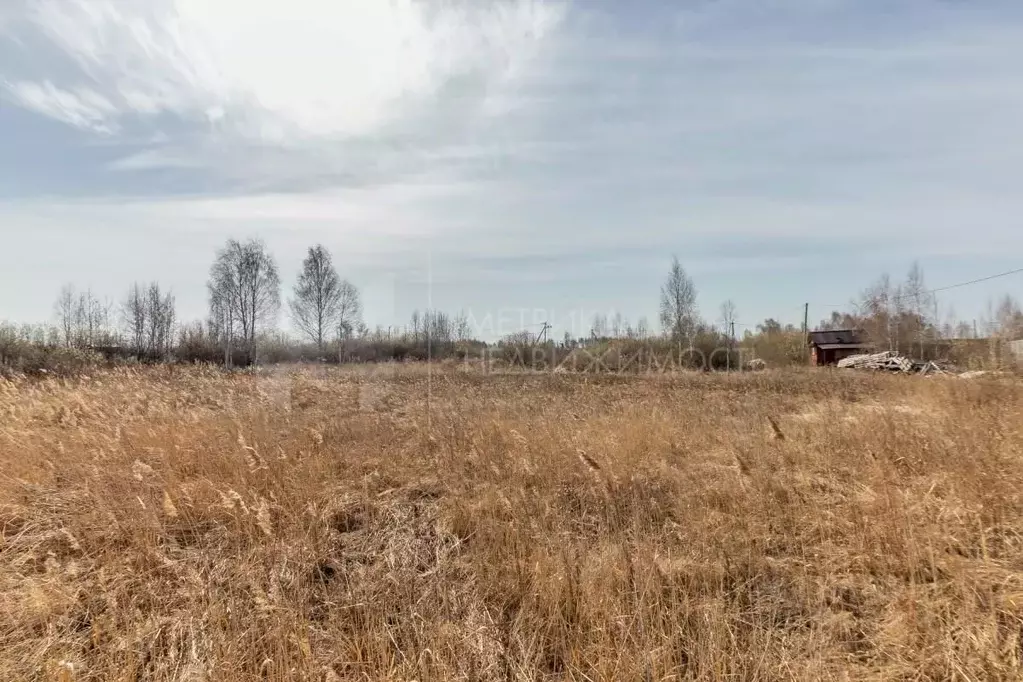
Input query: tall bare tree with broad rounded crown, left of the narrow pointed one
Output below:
<box><xmin>208</xmin><ymin>239</ymin><xmax>280</xmax><ymax>362</ymax></box>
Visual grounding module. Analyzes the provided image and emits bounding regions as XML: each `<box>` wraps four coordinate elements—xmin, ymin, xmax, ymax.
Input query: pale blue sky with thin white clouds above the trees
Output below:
<box><xmin>0</xmin><ymin>0</ymin><xmax>1023</xmax><ymax>337</ymax></box>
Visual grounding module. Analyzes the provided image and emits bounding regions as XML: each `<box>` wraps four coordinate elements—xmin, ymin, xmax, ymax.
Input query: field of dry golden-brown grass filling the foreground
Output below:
<box><xmin>0</xmin><ymin>368</ymin><xmax>1023</xmax><ymax>682</ymax></box>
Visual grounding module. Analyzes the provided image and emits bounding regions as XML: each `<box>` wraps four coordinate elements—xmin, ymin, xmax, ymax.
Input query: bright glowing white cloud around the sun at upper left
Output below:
<box><xmin>0</xmin><ymin>0</ymin><xmax>563</xmax><ymax>143</ymax></box>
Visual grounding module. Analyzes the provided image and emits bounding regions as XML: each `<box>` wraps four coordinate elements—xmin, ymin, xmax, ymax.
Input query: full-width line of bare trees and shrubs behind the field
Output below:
<box><xmin>0</xmin><ymin>239</ymin><xmax>1023</xmax><ymax>374</ymax></box>
